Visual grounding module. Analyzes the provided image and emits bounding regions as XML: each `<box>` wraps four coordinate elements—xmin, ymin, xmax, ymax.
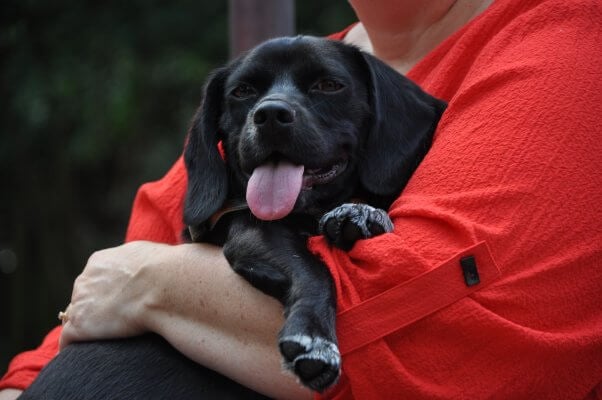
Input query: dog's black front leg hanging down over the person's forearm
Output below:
<box><xmin>224</xmin><ymin>218</ymin><xmax>341</xmax><ymax>391</ymax></box>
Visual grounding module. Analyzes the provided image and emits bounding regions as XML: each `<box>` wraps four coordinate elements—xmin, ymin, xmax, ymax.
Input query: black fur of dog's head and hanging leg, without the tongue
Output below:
<box><xmin>184</xmin><ymin>37</ymin><xmax>444</xmax><ymax>391</ymax></box>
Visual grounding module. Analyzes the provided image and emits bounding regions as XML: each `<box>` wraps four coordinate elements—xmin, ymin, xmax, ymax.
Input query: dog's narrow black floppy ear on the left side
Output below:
<box><xmin>184</xmin><ymin>68</ymin><xmax>228</xmax><ymax>227</ymax></box>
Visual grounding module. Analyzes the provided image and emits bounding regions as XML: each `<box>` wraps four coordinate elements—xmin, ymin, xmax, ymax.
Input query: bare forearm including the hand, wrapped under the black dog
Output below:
<box><xmin>61</xmin><ymin>241</ymin><xmax>311</xmax><ymax>399</ymax></box>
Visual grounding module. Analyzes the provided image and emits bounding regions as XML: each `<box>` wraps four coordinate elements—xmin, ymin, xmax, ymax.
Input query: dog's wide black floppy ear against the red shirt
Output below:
<box><xmin>359</xmin><ymin>53</ymin><xmax>446</xmax><ymax>196</ymax></box>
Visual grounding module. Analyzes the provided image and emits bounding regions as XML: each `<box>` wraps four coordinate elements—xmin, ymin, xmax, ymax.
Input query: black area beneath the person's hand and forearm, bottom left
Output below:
<box><xmin>19</xmin><ymin>334</ymin><xmax>267</xmax><ymax>400</ymax></box>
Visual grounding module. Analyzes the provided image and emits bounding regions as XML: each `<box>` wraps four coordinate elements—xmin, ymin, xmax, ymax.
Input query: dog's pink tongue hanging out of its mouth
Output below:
<box><xmin>247</xmin><ymin>161</ymin><xmax>303</xmax><ymax>221</ymax></box>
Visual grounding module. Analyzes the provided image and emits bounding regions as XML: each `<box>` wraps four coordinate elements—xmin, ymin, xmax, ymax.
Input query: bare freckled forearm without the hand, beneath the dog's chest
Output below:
<box><xmin>141</xmin><ymin>244</ymin><xmax>311</xmax><ymax>399</ymax></box>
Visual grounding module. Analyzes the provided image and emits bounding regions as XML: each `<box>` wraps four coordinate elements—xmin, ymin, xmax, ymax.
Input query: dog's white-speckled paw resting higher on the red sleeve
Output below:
<box><xmin>320</xmin><ymin>203</ymin><xmax>393</xmax><ymax>250</ymax></box>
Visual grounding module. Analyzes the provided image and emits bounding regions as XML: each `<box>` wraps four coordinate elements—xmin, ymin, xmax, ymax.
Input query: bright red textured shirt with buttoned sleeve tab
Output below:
<box><xmin>0</xmin><ymin>0</ymin><xmax>602</xmax><ymax>400</ymax></box>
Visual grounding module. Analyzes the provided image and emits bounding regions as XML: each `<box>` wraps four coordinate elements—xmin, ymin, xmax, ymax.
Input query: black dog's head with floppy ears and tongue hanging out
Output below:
<box><xmin>184</xmin><ymin>36</ymin><xmax>445</xmax><ymax>226</ymax></box>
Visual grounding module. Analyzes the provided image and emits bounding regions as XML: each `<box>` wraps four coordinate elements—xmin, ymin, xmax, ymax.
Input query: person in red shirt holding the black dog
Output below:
<box><xmin>0</xmin><ymin>0</ymin><xmax>602</xmax><ymax>399</ymax></box>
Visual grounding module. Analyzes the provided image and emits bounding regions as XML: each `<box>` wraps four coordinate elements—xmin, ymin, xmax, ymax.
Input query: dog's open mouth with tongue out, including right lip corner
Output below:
<box><xmin>247</xmin><ymin>160</ymin><xmax>347</xmax><ymax>221</ymax></box>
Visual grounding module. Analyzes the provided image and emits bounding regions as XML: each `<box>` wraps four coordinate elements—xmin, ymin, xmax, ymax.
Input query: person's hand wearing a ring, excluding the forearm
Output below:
<box><xmin>59</xmin><ymin>242</ymin><xmax>173</xmax><ymax>349</ymax></box>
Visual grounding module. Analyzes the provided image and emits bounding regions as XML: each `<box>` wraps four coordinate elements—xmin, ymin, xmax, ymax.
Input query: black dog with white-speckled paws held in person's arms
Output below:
<box><xmin>21</xmin><ymin>36</ymin><xmax>445</xmax><ymax>398</ymax></box>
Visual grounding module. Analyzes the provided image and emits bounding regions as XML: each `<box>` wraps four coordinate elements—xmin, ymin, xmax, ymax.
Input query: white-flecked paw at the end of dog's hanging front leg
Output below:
<box><xmin>280</xmin><ymin>335</ymin><xmax>341</xmax><ymax>392</ymax></box>
